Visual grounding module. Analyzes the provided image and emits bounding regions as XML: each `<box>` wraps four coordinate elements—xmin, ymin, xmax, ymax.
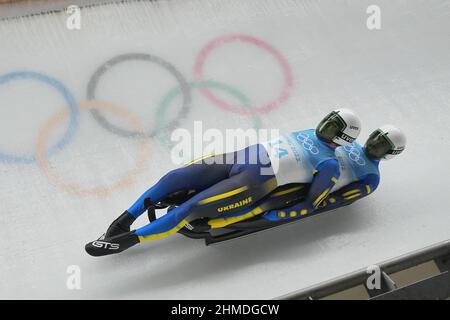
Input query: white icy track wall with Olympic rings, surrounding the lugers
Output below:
<box><xmin>0</xmin><ymin>0</ymin><xmax>450</xmax><ymax>298</ymax></box>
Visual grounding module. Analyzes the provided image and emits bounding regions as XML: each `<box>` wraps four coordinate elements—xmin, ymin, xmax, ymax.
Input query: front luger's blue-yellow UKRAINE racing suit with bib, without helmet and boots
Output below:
<box><xmin>127</xmin><ymin>129</ymin><xmax>340</xmax><ymax>242</ymax></box>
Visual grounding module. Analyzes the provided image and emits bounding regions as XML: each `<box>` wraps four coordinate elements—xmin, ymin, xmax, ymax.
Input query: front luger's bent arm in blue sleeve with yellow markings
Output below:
<box><xmin>264</xmin><ymin>159</ymin><xmax>340</xmax><ymax>221</ymax></box>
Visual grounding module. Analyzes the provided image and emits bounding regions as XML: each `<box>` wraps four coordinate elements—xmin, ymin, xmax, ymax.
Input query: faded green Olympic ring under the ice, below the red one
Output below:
<box><xmin>156</xmin><ymin>80</ymin><xmax>261</xmax><ymax>145</ymax></box>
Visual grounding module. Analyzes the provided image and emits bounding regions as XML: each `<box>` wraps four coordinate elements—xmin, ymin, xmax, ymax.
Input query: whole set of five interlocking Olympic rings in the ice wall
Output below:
<box><xmin>0</xmin><ymin>34</ymin><xmax>294</xmax><ymax>196</ymax></box>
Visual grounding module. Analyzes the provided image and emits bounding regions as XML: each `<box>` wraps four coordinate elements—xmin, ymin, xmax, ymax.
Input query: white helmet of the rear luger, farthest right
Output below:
<box><xmin>364</xmin><ymin>125</ymin><xmax>406</xmax><ymax>160</ymax></box>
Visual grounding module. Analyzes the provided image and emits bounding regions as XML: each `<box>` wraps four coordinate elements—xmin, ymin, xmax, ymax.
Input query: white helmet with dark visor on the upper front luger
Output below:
<box><xmin>316</xmin><ymin>109</ymin><xmax>361</xmax><ymax>146</ymax></box>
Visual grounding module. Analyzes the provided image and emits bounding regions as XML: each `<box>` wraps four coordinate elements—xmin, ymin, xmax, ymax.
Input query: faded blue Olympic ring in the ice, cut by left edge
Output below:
<box><xmin>0</xmin><ymin>71</ymin><xmax>78</xmax><ymax>164</ymax></box>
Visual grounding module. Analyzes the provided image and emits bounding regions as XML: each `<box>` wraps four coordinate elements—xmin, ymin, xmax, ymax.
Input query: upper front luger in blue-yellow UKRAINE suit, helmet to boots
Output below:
<box><xmin>86</xmin><ymin>109</ymin><xmax>361</xmax><ymax>256</ymax></box>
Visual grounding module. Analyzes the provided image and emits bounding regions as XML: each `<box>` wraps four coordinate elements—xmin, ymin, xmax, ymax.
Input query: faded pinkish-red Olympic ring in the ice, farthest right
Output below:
<box><xmin>194</xmin><ymin>34</ymin><xmax>294</xmax><ymax>115</ymax></box>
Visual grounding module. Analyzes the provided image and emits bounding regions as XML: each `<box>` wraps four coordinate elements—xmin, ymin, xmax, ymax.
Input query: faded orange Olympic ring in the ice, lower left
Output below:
<box><xmin>36</xmin><ymin>100</ymin><xmax>149</xmax><ymax>196</ymax></box>
